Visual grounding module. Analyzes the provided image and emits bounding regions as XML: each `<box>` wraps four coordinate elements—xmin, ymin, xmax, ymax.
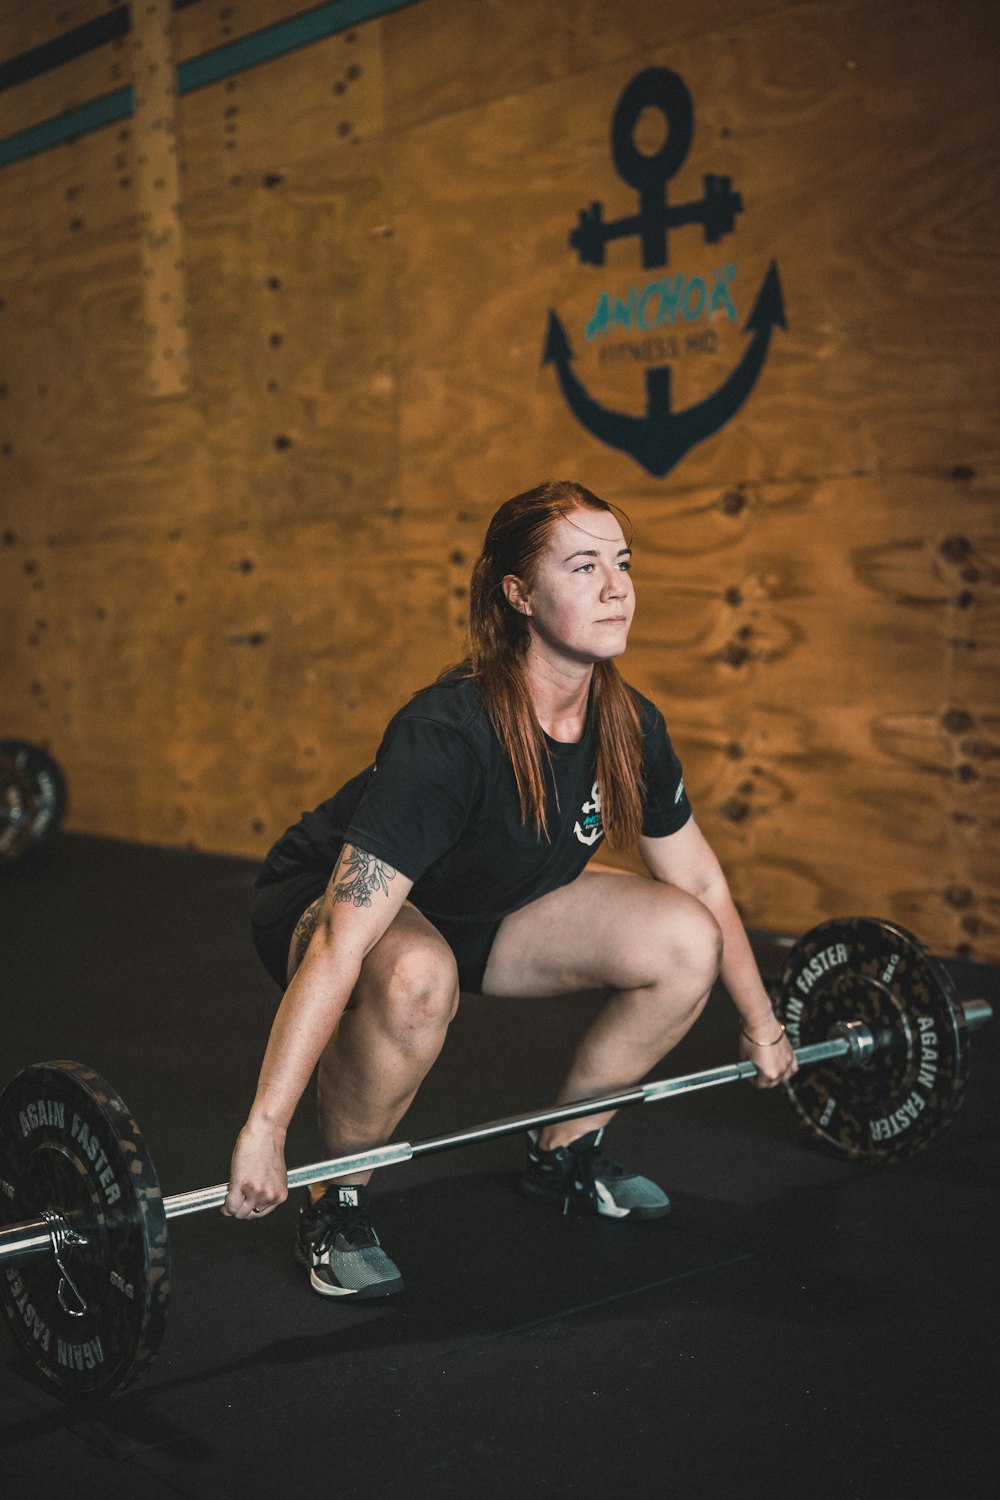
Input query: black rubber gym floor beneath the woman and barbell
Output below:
<box><xmin>0</xmin><ymin>837</ymin><xmax>1000</xmax><ymax>1500</ymax></box>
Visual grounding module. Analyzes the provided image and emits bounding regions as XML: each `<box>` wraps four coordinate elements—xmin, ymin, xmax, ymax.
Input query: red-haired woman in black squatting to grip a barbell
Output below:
<box><xmin>223</xmin><ymin>483</ymin><xmax>796</xmax><ymax>1298</ymax></box>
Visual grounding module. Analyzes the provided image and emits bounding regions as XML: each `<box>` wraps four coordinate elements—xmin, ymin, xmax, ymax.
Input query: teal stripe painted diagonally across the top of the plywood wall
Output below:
<box><xmin>0</xmin><ymin>0</ymin><xmax>418</xmax><ymax>167</ymax></box>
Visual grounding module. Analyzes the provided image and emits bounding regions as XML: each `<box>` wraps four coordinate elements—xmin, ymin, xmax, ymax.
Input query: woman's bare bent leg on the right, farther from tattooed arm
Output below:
<box><xmin>483</xmin><ymin>869</ymin><xmax>721</xmax><ymax>1151</ymax></box>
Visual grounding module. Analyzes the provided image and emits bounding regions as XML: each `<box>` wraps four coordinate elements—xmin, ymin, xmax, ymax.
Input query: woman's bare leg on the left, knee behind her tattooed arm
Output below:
<box><xmin>289</xmin><ymin>906</ymin><xmax>459</xmax><ymax>1197</ymax></box>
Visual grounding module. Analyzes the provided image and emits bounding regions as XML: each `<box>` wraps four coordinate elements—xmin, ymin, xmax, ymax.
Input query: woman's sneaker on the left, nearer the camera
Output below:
<box><xmin>295</xmin><ymin>1187</ymin><xmax>403</xmax><ymax>1299</ymax></box>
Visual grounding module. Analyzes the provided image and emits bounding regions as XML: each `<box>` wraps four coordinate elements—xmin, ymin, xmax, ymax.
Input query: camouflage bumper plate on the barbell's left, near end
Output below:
<box><xmin>0</xmin><ymin>1062</ymin><xmax>169</xmax><ymax>1397</ymax></box>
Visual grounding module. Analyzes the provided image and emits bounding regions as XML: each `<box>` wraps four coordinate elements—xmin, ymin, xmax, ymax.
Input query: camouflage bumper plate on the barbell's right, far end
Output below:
<box><xmin>777</xmin><ymin>917</ymin><xmax>969</xmax><ymax>1163</ymax></box>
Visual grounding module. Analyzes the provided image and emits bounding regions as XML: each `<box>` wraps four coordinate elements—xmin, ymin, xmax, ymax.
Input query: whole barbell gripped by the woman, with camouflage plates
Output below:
<box><xmin>0</xmin><ymin>918</ymin><xmax>993</xmax><ymax>1398</ymax></box>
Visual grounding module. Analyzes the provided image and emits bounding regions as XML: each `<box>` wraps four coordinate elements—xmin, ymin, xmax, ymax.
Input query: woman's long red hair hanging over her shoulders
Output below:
<box><xmin>469</xmin><ymin>480</ymin><xmax>645</xmax><ymax>849</ymax></box>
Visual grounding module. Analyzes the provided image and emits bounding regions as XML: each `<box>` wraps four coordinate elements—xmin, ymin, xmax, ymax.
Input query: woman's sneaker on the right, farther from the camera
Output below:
<box><xmin>520</xmin><ymin>1130</ymin><xmax>670</xmax><ymax>1218</ymax></box>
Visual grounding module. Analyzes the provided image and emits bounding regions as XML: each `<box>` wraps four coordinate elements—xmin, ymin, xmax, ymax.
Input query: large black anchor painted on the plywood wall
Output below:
<box><xmin>541</xmin><ymin>68</ymin><xmax>787</xmax><ymax>479</ymax></box>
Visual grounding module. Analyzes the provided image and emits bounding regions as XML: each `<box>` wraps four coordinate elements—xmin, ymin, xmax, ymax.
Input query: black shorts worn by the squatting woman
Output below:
<box><xmin>250</xmin><ymin>870</ymin><xmax>502</xmax><ymax>995</ymax></box>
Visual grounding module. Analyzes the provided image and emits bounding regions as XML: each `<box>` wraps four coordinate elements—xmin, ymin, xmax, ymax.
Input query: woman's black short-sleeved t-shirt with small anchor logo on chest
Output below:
<box><xmin>258</xmin><ymin>674</ymin><xmax>691</xmax><ymax>921</ymax></box>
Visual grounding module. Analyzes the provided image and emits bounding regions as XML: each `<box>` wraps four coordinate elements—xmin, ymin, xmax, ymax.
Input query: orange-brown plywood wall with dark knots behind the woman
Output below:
<box><xmin>0</xmin><ymin>0</ymin><xmax>1000</xmax><ymax>959</ymax></box>
